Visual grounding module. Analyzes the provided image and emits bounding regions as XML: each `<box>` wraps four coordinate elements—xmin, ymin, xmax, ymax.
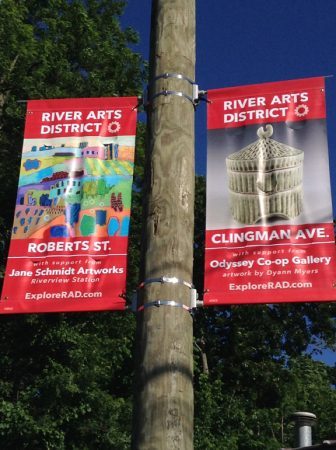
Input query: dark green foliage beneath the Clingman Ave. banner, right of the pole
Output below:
<box><xmin>196</xmin><ymin>305</ymin><xmax>336</xmax><ymax>450</ymax></box>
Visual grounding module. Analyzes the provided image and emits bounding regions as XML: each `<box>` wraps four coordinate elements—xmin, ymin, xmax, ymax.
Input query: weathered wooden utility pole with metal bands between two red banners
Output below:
<box><xmin>132</xmin><ymin>0</ymin><xmax>195</xmax><ymax>450</ymax></box>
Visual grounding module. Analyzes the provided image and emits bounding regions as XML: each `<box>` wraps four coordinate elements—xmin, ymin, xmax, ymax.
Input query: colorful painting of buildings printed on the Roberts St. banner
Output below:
<box><xmin>13</xmin><ymin>142</ymin><xmax>134</xmax><ymax>239</ymax></box>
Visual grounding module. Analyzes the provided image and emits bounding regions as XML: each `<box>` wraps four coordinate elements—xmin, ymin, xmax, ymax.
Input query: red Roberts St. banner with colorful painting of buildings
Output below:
<box><xmin>0</xmin><ymin>97</ymin><xmax>137</xmax><ymax>314</ymax></box>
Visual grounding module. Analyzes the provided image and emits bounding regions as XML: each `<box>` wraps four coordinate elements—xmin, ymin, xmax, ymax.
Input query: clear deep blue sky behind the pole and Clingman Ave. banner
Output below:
<box><xmin>121</xmin><ymin>0</ymin><xmax>336</xmax><ymax>364</ymax></box>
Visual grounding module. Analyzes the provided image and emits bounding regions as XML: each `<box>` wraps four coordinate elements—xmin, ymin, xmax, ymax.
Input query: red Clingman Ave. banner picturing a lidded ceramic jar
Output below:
<box><xmin>204</xmin><ymin>78</ymin><xmax>336</xmax><ymax>306</ymax></box>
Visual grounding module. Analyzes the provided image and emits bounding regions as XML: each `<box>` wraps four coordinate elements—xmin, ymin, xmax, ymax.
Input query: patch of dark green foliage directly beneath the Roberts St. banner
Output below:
<box><xmin>0</xmin><ymin>313</ymin><xmax>133</xmax><ymax>450</ymax></box>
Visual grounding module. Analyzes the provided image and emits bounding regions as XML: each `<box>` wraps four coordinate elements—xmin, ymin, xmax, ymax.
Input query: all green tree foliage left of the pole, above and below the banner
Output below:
<box><xmin>0</xmin><ymin>0</ymin><xmax>144</xmax><ymax>450</ymax></box>
